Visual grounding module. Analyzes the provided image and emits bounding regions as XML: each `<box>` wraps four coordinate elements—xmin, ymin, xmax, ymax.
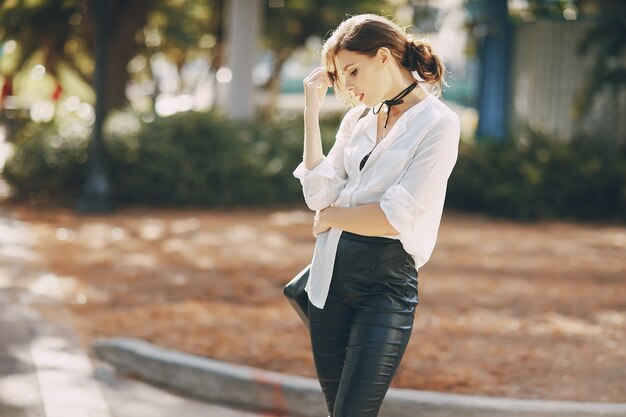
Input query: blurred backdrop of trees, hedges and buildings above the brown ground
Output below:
<box><xmin>0</xmin><ymin>0</ymin><xmax>626</xmax><ymax>220</ymax></box>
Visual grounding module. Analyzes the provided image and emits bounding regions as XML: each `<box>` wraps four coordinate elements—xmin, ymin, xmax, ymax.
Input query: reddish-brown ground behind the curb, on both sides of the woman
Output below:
<box><xmin>12</xmin><ymin>206</ymin><xmax>626</xmax><ymax>402</ymax></box>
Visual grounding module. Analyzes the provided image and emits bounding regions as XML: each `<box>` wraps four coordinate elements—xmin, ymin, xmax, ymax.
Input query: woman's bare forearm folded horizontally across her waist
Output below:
<box><xmin>313</xmin><ymin>203</ymin><xmax>398</xmax><ymax>236</ymax></box>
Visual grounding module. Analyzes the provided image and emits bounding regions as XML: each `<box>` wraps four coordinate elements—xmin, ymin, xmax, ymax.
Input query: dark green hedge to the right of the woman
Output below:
<box><xmin>446</xmin><ymin>136</ymin><xmax>626</xmax><ymax>221</ymax></box>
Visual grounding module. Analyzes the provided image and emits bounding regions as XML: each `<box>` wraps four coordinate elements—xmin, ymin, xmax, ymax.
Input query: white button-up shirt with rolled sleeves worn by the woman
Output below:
<box><xmin>293</xmin><ymin>94</ymin><xmax>460</xmax><ymax>308</ymax></box>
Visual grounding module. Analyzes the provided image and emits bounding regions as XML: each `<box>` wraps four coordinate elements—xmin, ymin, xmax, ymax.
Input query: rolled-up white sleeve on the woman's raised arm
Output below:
<box><xmin>293</xmin><ymin>106</ymin><xmax>364</xmax><ymax>210</ymax></box>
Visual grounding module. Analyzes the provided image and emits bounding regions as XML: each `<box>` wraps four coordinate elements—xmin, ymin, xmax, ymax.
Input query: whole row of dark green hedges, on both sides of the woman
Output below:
<box><xmin>4</xmin><ymin>112</ymin><xmax>626</xmax><ymax>221</ymax></box>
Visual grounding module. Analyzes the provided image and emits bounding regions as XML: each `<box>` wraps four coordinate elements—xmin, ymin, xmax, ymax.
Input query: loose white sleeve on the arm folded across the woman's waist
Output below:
<box><xmin>380</xmin><ymin>116</ymin><xmax>460</xmax><ymax>265</ymax></box>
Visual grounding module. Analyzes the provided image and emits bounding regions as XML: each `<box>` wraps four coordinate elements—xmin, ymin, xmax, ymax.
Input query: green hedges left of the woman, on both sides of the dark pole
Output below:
<box><xmin>4</xmin><ymin>112</ymin><xmax>338</xmax><ymax>207</ymax></box>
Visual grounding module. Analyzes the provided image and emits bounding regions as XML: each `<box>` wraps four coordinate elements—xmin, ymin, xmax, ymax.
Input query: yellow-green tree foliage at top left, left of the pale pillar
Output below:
<box><xmin>0</xmin><ymin>0</ymin><xmax>219</xmax><ymax>109</ymax></box>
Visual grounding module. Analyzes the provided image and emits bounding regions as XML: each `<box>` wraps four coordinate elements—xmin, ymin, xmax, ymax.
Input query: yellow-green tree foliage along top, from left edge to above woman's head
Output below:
<box><xmin>0</xmin><ymin>0</ymin><xmax>396</xmax><ymax>109</ymax></box>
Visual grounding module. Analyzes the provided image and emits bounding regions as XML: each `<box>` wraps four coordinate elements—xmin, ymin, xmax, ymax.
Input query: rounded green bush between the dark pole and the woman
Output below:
<box><xmin>111</xmin><ymin>109</ymin><xmax>302</xmax><ymax>206</ymax></box>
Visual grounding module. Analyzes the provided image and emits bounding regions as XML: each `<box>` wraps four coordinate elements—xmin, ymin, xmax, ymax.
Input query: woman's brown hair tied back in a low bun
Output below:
<box><xmin>322</xmin><ymin>14</ymin><xmax>447</xmax><ymax>102</ymax></box>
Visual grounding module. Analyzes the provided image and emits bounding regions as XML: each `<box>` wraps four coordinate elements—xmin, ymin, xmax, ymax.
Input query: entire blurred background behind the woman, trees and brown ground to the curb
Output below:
<box><xmin>0</xmin><ymin>0</ymin><xmax>626</xmax><ymax>413</ymax></box>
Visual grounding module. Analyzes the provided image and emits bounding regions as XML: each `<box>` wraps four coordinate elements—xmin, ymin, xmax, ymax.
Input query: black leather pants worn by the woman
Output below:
<box><xmin>309</xmin><ymin>232</ymin><xmax>417</xmax><ymax>417</ymax></box>
